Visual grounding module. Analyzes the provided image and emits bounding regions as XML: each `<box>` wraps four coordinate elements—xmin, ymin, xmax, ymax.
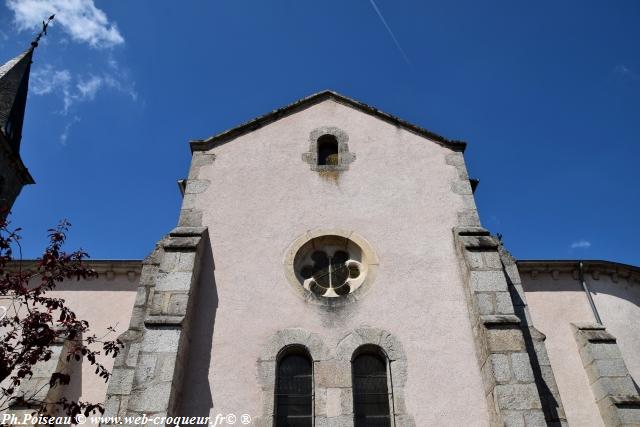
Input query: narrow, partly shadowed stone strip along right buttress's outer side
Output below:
<box><xmin>498</xmin><ymin>245</ymin><xmax>568</xmax><ymax>426</ymax></box>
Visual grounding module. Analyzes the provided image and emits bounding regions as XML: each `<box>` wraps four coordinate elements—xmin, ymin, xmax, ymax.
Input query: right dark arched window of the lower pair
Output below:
<box><xmin>351</xmin><ymin>346</ymin><xmax>393</xmax><ymax>427</ymax></box>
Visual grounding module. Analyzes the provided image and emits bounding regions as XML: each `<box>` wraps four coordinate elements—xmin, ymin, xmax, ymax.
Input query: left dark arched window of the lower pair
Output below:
<box><xmin>274</xmin><ymin>346</ymin><xmax>313</xmax><ymax>427</ymax></box>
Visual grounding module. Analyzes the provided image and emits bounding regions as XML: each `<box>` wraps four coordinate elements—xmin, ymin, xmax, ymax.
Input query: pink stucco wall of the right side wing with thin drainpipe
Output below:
<box><xmin>522</xmin><ymin>268</ymin><xmax>640</xmax><ymax>426</ymax></box>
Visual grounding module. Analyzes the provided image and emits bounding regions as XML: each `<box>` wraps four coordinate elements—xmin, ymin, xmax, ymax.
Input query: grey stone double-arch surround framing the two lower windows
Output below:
<box><xmin>252</xmin><ymin>327</ymin><xmax>416</xmax><ymax>427</ymax></box>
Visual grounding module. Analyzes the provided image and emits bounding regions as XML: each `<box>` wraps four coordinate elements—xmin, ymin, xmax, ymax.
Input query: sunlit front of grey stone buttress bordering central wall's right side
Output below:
<box><xmin>454</xmin><ymin>227</ymin><xmax>547</xmax><ymax>427</ymax></box>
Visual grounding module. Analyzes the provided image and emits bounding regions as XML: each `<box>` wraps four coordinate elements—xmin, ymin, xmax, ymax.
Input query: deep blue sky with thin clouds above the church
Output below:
<box><xmin>0</xmin><ymin>0</ymin><xmax>640</xmax><ymax>265</ymax></box>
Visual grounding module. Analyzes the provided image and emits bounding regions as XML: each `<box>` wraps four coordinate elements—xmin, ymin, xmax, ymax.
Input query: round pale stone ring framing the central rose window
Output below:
<box><xmin>284</xmin><ymin>228</ymin><xmax>380</xmax><ymax>307</ymax></box>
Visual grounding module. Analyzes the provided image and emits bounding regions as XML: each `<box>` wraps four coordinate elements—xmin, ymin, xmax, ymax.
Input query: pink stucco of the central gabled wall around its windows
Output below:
<box><xmin>180</xmin><ymin>100</ymin><xmax>488</xmax><ymax>426</ymax></box>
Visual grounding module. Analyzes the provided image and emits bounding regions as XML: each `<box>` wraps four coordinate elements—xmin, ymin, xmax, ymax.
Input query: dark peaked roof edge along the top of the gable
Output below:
<box><xmin>190</xmin><ymin>90</ymin><xmax>467</xmax><ymax>152</ymax></box>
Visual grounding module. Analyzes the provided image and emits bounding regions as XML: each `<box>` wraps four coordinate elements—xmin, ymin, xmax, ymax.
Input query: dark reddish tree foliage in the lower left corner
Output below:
<box><xmin>0</xmin><ymin>215</ymin><xmax>123</xmax><ymax>417</ymax></box>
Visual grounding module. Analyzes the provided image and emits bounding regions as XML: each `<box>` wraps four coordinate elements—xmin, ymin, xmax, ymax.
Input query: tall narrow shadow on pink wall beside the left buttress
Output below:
<box><xmin>180</xmin><ymin>233</ymin><xmax>218</xmax><ymax>417</ymax></box>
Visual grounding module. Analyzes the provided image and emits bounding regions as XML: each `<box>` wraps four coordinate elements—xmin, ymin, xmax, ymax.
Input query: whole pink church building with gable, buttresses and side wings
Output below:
<box><xmin>1</xmin><ymin>46</ymin><xmax>640</xmax><ymax>427</ymax></box>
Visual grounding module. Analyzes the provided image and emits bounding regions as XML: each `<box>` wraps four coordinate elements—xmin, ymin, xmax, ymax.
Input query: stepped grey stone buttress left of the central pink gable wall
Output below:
<box><xmin>105</xmin><ymin>227</ymin><xmax>207</xmax><ymax>424</ymax></box>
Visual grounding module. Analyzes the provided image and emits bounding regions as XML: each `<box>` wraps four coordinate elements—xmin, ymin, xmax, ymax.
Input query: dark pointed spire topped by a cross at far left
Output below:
<box><xmin>0</xmin><ymin>15</ymin><xmax>54</xmax><ymax>153</ymax></box>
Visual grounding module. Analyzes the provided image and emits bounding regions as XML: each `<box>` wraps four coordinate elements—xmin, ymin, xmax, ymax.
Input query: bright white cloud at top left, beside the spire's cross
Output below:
<box><xmin>6</xmin><ymin>0</ymin><xmax>124</xmax><ymax>48</ymax></box>
